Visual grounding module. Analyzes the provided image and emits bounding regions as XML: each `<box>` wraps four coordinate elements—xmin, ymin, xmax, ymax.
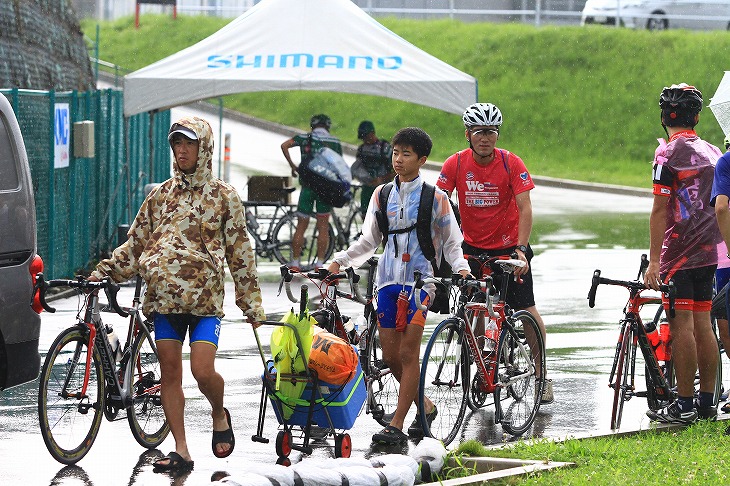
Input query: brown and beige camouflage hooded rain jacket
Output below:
<box><xmin>92</xmin><ymin>117</ymin><xmax>265</xmax><ymax>321</ymax></box>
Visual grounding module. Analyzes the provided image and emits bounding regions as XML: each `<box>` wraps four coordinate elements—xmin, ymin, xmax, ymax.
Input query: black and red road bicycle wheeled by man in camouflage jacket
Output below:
<box><xmin>34</xmin><ymin>273</ymin><xmax>170</xmax><ymax>464</ymax></box>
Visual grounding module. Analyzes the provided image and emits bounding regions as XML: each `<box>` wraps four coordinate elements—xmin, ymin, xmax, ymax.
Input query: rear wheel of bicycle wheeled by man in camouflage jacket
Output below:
<box><xmin>127</xmin><ymin>326</ymin><xmax>170</xmax><ymax>449</ymax></box>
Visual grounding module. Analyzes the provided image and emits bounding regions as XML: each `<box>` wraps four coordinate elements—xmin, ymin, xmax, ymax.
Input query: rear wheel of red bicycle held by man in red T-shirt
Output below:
<box><xmin>494</xmin><ymin>311</ymin><xmax>545</xmax><ymax>435</ymax></box>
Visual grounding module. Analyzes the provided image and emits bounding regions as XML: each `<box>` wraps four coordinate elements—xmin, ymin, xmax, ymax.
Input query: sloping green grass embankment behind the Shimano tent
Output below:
<box><xmin>82</xmin><ymin>15</ymin><xmax>730</xmax><ymax>187</ymax></box>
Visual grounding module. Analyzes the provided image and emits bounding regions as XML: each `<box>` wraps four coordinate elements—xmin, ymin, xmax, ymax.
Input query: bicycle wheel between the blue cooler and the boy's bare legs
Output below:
<box><xmin>360</xmin><ymin>313</ymin><xmax>399</xmax><ymax>427</ymax></box>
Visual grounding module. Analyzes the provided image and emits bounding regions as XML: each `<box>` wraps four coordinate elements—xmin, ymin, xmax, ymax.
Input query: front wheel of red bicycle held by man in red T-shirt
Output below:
<box><xmin>418</xmin><ymin>318</ymin><xmax>470</xmax><ymax>445</ymax></box>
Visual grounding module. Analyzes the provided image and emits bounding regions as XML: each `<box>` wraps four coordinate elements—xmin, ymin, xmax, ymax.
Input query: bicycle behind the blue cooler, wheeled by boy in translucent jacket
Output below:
<box><xmin>282</xmin><ymin>257</ymin><xmax>398</xmax><ymax>426</ymax></box>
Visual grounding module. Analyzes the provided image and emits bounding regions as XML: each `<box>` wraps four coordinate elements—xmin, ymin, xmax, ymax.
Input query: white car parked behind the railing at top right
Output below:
<box><xmin>580</xmin><ymin>0</ymin><xmax>730</xmax><ymax>30</ymax></box>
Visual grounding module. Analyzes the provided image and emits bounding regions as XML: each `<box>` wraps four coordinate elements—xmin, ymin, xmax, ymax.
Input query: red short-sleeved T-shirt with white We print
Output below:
<box><xmin>436</xmin><ymin>148</ymin><xmax>535</xmax><ymax>250</ymax></box>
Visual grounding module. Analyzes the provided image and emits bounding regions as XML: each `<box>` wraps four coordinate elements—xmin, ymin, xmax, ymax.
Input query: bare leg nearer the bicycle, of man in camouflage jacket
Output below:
<box><xmin>157</xmin><ymin>340</ymin><xmax>191</xmax><ymax>461</ymax></box>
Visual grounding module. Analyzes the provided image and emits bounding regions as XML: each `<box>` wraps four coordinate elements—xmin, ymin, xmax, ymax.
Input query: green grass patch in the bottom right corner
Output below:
<box><xmin>452</xmin><ymin>422</ymin><xmax>730</xmax><ymax>486</ymax></box>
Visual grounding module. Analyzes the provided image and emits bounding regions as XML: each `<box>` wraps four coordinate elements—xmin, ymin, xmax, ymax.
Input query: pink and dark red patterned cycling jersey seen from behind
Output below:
<box><xmin>653</xmin><ymin>130</ymin><xmax>721</xmax><ymax>276</ymax></box>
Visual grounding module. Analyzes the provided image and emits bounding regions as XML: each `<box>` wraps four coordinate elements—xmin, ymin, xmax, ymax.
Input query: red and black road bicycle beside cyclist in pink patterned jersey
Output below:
<box><xmin>588</xmin><ymin>254</ymin><xmax>722</xmax><ymax>430</ymax></box>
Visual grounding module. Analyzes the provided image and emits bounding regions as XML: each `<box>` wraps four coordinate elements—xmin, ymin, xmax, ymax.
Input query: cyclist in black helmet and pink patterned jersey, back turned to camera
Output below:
<box><xmin>645</xmin><ymin>83</ymin><xmax>721</xmax><ymax>424</ymax></box>
